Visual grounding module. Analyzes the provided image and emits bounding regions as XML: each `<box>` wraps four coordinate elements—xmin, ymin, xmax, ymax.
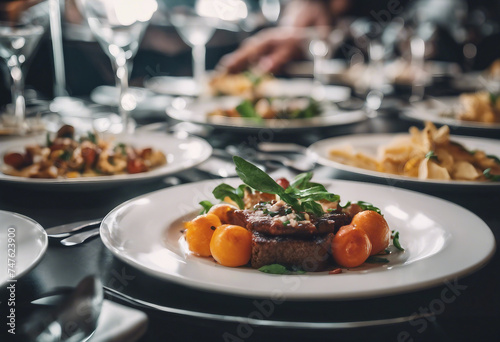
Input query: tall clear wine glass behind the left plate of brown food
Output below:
<box><xmin>79</xmin><ymin>0</ymin><xmax>158</xmax><ymax>133</ymax></box>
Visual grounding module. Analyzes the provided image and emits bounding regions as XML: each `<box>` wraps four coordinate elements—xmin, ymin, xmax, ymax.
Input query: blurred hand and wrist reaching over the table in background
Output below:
<box><xmin>219</xmin><ymin>0</ymin><xmax>349</xmax><ymax>73</ymax></box>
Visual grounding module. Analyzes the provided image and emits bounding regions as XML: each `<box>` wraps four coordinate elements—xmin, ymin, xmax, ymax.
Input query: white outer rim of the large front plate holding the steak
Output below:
<box><xmin>100</xmin><ymin>178</ymin><xmax>496</xmax><ymax>300</ymax></box>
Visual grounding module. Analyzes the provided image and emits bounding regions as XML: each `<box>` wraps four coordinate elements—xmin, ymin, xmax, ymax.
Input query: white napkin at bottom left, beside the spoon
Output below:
<box><xmin>89</xmin><ymin>300</ymin><xmax>148</xmax><ymax>342</ymax></box>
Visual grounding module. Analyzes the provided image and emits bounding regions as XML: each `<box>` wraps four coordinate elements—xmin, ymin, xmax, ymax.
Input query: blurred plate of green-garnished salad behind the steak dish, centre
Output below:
<box><xmin>166</xmin><ymin>96</ymin><xmax>366</xmax><ymax>131</ymax></box>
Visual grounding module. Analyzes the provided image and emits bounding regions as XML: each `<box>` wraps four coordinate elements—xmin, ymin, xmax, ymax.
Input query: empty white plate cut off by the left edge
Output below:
<box><xmin>0</xmin><ymin>210</ymin><xmax>48</xmax><ymax>287</ymax></box>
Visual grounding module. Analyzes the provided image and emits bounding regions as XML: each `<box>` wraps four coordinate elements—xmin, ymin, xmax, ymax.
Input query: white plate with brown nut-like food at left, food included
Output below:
<box><xmin>0</xmin><ymin>125</ymin><xmax>212</xmax><ymax>190</ymax></box>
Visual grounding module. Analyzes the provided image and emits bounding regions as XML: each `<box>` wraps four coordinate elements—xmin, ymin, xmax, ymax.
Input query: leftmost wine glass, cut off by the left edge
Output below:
<box><xmin>0</xmin><ymin>0</ymin><xmax>48</xmax><ymax>134</ymax></box>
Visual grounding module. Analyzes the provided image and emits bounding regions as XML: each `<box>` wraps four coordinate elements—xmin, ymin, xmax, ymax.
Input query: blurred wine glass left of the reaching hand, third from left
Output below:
<box><xmin>168</xmin><ymin>0</ymin><xmax>248</xmax><ymax>95</ymax></box>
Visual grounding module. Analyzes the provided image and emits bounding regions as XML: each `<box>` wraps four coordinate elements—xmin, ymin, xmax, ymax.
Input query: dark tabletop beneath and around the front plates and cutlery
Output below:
<box><xmin>0</xmin><ymin>100</ymin><xmax>500</xmax><ymax>342</ymax></box>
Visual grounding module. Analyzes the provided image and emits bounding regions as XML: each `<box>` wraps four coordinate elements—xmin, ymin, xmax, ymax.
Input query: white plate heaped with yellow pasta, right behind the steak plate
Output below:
<box><xmin>308</xmin><ymin>122</ymin><xmax>500</xmax><ymax>189</ymax></box>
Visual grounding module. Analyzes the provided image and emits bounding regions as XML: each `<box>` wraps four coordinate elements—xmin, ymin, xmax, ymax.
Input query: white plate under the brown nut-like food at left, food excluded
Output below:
<box><xmin>0</xmin><ymin>132</ymin><xmax>212</xmax><ymax>190</ymax></box>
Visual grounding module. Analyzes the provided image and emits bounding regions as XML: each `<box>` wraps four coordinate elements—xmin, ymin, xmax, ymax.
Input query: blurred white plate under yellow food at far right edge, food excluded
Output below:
<box><xmin>401</xmin><ymin>97</ymin><xmax>500</xmax><ymax>130</ymax></box>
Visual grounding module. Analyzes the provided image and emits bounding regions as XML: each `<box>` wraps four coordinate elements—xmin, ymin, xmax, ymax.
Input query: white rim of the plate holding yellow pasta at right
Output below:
<box><xmin>306</xmin><ymin>132</ymin><xmax>500</xmax><ymax>188</ymax></box>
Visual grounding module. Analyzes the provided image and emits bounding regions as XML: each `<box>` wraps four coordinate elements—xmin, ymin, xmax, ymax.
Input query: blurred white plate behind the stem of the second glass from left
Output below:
<box><xmin>90</xmin><ymin>86</ymin><xmax>172</xmax><ymax>111</ymax></box>
